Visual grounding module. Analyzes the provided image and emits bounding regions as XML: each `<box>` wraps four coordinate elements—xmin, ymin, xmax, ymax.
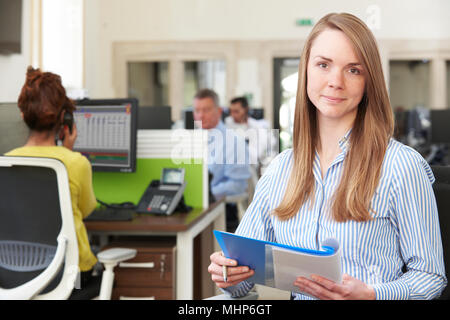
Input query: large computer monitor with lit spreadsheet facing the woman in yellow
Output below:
<box><xmin>73</xmin><ymin>98</ymin><xmax>138</xmax><ymax>172</ymax></box>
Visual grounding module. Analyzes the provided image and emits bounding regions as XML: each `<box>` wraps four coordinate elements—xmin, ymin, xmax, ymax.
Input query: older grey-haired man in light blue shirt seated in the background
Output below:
<box><xmin>193</xmin><ymin>89</ymin><xmax>250</xmax><ymax>231</ymax></box>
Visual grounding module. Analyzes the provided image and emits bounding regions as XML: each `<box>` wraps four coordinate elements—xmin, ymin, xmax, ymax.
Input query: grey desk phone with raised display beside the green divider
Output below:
<box><xmin>136</xmin><ymin>168</ymin><xmax>186</xmax><ymax>215</ymax></box>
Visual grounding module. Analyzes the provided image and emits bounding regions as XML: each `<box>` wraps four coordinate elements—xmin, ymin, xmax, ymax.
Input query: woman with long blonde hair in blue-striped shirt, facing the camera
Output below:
<box><xmin>208</xmin><ymin>13</ymin><xmax>447</xmax><ymax>299</ymax></box>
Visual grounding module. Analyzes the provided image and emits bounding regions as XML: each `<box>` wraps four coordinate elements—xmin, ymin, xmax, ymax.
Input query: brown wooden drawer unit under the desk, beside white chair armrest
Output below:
<box><xmin>108</xmin><ymin>242</ymin><xmax>176</xmax><ymax>300</ymax></box>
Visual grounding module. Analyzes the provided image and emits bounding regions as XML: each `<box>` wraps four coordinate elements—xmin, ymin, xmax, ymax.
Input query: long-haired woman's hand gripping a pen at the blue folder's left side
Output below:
<box><xmin>208</xmin><ymin>252</ymin><xmax>255</xmax><ymax>288</ymax></box>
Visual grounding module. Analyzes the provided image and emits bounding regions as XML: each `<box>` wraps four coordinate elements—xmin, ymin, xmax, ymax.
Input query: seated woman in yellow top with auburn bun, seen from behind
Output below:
<box><xmin>6</xmin><ymin>67</ymin><xmax>97</xmax><ymax>294</ymax></box>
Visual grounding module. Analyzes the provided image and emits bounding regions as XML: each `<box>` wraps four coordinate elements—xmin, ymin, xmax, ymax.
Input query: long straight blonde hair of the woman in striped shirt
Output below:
<box><xmin>274</xmin><ymin>13</ymin><xmax>394</xmax><ymax>222</ymax></box>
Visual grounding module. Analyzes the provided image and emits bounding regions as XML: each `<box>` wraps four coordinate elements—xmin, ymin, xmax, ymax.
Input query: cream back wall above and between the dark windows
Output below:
<box><xmin>85</xmin><ymin>0</ymin><xmax>450</xmax><ymax>122</ymax></box>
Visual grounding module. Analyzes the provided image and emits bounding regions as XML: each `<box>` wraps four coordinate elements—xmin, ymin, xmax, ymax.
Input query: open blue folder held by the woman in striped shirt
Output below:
<box><xmin>213</xmin><ymin>230</ymin><xmax>335</xmax><ymax>285</ymax></box>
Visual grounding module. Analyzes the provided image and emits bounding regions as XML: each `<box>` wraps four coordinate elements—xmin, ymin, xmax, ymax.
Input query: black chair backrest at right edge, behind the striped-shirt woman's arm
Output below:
<box><xmin>431</xmin><ymin>166</ymin><xmax>450</xmax><ymax>300</ymax></box>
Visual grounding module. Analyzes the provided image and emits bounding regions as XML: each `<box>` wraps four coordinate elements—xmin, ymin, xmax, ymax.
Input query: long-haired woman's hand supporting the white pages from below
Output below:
<box><xmin>294</xmin><ymin>274</ymin><xmax>376</xmax><ymax>300</ymax></box>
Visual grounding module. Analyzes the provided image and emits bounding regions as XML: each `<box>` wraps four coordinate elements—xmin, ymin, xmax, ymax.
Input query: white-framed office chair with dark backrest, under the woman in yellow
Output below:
<box><xmin>0</xmin><ymin>156</ymin><xmax>136</xmax><ymax>300</ymax></box>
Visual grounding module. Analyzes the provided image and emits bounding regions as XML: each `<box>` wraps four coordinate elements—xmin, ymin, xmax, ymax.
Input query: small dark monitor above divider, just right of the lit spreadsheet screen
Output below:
<box><xmin>138</xmin><ymin>106</ymin><xmax>172</xmax><ymax>129</ymax></box>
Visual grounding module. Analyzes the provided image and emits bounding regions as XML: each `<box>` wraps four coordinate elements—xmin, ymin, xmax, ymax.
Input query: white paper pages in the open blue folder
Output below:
<box><xmin>272</xmin><ymin>239</ymin><xmax>342</xmax><ymax>292</ymax></box>
